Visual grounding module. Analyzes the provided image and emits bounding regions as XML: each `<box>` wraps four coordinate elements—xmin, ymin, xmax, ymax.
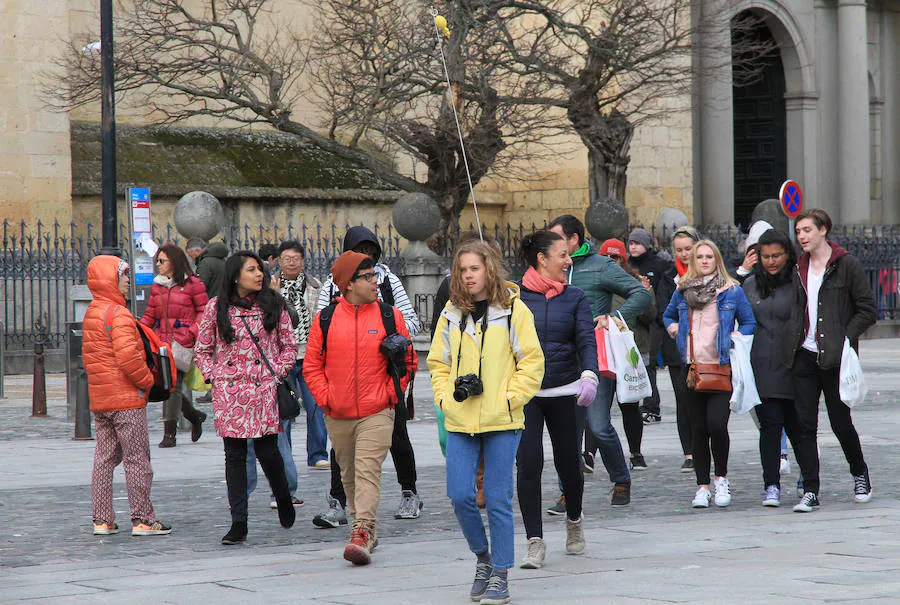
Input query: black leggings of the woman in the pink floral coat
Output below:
<box><xmin>222</xmin><ymin>435</ymin><xmax>291</xmax><ymax>523</ymax></box>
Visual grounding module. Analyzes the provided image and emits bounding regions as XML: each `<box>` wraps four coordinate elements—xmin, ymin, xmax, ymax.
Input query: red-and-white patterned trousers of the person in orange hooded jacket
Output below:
<box><xmin>91</xmin><ymin>408</ymin><xmax>156</xmax><ymax>523</ymax></box>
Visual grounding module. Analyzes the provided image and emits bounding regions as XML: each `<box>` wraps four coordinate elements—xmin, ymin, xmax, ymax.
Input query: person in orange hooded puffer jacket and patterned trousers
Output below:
<box><xmin>82</xmin><ymin>256</ymin><xmax>172</xmax><ymax>536</ymax></box>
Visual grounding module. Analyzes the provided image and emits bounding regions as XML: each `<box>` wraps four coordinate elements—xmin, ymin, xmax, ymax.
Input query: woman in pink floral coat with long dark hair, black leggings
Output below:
<box><xmin>194</xmin><ymin>252</ymin><xmax>297</xmax><ymax>544</ymax></box>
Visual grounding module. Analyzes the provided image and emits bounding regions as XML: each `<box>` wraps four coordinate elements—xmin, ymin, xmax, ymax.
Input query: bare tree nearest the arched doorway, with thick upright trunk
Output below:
<box><xmin>486</xmin><ymin>0</ymin><xmax>774</xmax><ymax>201</ymax></box>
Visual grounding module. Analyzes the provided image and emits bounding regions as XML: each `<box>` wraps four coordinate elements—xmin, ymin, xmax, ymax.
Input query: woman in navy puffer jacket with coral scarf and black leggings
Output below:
<box><xmin>517</xmin><ymin>230</ymin><xmax>599</xmax><ymax>569</ymax></box>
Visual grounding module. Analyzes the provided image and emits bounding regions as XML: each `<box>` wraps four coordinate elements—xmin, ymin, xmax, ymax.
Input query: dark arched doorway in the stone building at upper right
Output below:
<box><xmin>732</xmin><ymin>11</ymin><xmax>787</xmax><ymax>228</ymax></box>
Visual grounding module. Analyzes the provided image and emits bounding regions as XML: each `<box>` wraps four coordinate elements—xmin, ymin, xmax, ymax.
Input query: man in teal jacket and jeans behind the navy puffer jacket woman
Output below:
<box><xmin>548</xmin><ymin>214</ymin><xmax>652</xmax><ymax>504</ymax></box>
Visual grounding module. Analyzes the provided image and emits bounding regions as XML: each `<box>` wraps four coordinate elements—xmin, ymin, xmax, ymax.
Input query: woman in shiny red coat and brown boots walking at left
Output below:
<box><xmin>141</xmin><ymin>244</ymin><xmax>209</xmax><ymax>447</ymax></box>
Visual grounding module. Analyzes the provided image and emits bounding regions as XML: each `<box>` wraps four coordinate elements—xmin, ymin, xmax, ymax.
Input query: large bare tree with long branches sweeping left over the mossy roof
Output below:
<box><xmin>44</xmin><ymin>0</ymin><xmax>563</xmax><ymax>238</ymax></box>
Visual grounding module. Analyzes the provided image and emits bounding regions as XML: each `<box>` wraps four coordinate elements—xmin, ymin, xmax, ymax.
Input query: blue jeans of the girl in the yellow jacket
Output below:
<box><xmin>447</xmin><ymin>431</ymin><xmax>522</xmax><ymax>571</ymax></box>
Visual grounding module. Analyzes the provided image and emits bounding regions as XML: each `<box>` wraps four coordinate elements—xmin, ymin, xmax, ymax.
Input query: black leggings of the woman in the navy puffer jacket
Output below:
<box><xmin>516</xmin><ymin>396</ymin><xmax>588</xmax><ymax>538</ymax></box>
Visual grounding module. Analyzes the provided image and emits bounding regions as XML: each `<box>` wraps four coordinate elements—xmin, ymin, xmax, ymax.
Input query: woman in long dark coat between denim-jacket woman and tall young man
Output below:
<box><xmin>743</xmin><ymin>229</ymin><xmax>817</xmax><ymax>506</ymax></box>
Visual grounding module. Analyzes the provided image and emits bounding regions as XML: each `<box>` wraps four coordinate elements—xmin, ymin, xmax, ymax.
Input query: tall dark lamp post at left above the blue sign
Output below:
<box><xmin>100</xmin><ymin>0</ymin><xmax>121</xmax><ymax>256</ymax></box>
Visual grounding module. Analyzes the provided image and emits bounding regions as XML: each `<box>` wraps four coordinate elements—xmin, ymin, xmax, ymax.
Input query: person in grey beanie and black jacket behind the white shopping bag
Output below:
<box><xmin>628</xmin><ymin>229</ymin><xmax>681</xmax><ymax>424</ymax></box>
